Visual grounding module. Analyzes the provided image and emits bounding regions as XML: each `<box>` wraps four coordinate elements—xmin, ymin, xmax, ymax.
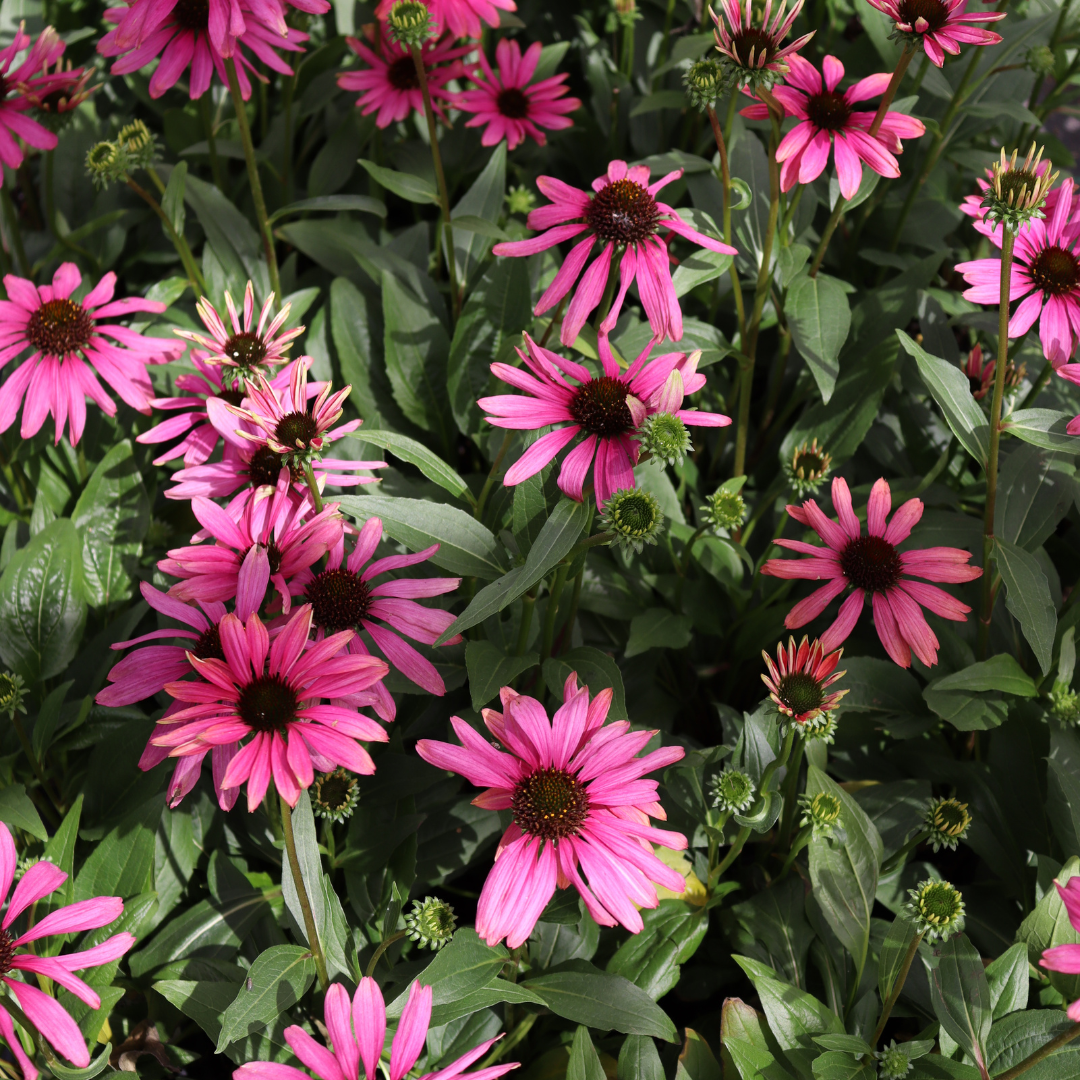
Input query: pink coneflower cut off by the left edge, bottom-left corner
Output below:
<box><xmin>0</xmin><ymin>822</ymin><xmax>135</xmax><ymax>1080</ymax></box>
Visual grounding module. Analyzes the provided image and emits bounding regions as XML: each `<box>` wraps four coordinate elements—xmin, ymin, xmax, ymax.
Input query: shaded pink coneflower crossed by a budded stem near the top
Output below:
<box><xmin>338</xmin><ymin>27</ymin><xmax>474</xmax><ymax>127</ymax></box>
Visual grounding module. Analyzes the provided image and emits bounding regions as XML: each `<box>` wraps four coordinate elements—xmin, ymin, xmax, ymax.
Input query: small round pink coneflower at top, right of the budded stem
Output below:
<box><xmin>455</xmin><ymin>38</ymin><xmax>581</xmax><ymax>150</ymax></box>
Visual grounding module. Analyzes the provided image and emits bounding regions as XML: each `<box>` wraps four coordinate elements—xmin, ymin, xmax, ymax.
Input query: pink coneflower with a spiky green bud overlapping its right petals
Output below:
<box><xmin>477</xmin><ymin>334</ymin><xmax>731</xmax><ymax>509</ymax></box>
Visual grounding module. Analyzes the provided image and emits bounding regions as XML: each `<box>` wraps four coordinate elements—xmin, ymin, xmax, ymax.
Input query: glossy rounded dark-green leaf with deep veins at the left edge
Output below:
<box><xmin>0</xmin><ymin>517</ymin><xmax>86</xmax><ymax>685</ymax></box>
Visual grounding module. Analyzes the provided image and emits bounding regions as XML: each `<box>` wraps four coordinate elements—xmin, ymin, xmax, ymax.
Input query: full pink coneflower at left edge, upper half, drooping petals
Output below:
<box><xmin>0</xmin><ymin>262</ymin><xmax>178</xmax><ymax>446</ymax></box>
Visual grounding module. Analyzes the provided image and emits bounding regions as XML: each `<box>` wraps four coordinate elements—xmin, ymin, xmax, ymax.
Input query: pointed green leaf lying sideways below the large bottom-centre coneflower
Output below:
<box><xmin>523</xmin><ymin>960</ymin><xmax>676</xmax><ymax>1042</ymax></box>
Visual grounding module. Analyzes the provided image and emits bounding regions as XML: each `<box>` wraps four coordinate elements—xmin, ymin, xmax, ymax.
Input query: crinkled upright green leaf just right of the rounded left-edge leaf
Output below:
<box><xmin>71</xmin><ymin>438</ymin><xmax>150</xmax><ymax>607</ymax></box>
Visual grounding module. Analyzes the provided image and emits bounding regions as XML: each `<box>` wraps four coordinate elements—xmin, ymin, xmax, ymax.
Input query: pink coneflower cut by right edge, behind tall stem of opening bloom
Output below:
<box><xmin>956</xmin><ymin>179</ymin><xmax>1080</xmax><ymax>367</ymax></box>
